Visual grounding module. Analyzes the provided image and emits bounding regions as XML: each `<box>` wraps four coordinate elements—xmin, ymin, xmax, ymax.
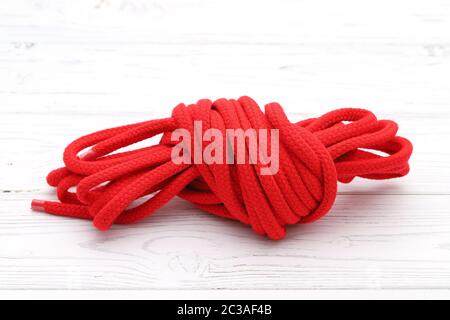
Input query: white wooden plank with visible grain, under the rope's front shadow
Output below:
<box><xmin>0</xmin><ymin>195</ymin><xmax>450</xmax><ymax>289</ymax></box>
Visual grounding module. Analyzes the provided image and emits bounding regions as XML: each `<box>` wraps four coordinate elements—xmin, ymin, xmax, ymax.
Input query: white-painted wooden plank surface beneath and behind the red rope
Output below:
<box><xmin>0</xmin><ymin>0</ymin><xmax>450</xmax><ymax>296</ymax></box>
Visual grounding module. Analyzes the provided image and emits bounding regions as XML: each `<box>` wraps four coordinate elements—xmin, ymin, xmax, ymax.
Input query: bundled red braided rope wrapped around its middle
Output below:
<box><xmin>32</xmin><ymin>97</ymin><xmax>412</xmax><ymax>239</ymax></box>
